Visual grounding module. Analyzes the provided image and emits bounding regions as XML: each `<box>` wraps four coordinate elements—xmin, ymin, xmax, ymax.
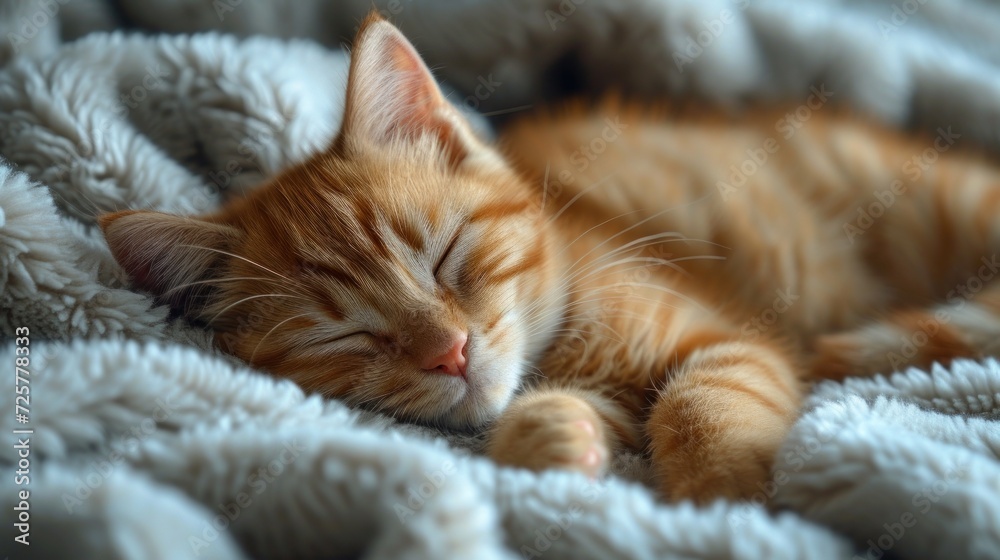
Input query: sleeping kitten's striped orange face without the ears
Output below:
<box><xmin>218</xmin><ymin>142</ymin><xmax>546</xmax><ymax>425</ymax></box>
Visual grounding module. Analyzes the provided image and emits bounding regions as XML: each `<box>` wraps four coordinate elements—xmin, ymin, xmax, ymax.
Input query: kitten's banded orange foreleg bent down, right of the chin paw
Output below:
<box><xmin>646</xmin><ymin>342</ymin><xmax>803</xmax><ymax>503</ymax></box>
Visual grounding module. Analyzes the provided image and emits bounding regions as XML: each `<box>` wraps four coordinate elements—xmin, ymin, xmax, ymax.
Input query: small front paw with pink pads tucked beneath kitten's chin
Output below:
<box><xmin>488</xmin><ymin>393</ymin><xmax>610</xmax><ymax>478</ymax></box>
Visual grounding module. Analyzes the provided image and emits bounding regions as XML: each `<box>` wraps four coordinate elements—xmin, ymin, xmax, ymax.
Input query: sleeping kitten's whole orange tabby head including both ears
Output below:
<box><xmin>101</xmin><ymin>14</ymin><xmax>558</xmax><ymax>427</ymax></box>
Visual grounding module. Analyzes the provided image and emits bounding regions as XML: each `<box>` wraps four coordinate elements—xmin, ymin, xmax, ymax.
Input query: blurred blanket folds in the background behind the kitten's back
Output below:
<box><xmin>13</xmin><ymin>0</ymin><xmax>1000</xmax><ymax>148</ymax></box>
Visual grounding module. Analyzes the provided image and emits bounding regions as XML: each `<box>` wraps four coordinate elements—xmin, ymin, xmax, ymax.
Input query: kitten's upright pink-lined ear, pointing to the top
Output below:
<box><xmin>335</xmin><ymin>14</ymin><xmax>485</xmax><ymax>163</ymax></box>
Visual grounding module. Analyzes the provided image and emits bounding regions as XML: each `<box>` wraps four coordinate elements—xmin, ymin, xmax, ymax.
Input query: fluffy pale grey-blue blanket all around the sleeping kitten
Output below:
<box><xmin>0</xmin><ymin>0</ymin><xmax>1000</xmax><ymax>559</ymax></box>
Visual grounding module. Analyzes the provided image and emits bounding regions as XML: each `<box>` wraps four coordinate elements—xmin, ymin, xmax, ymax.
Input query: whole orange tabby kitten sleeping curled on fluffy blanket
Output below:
<box><xmin>100</xmin><ymin>14</ymin><xmax>1000</xmax><ymax>502</ymax></box>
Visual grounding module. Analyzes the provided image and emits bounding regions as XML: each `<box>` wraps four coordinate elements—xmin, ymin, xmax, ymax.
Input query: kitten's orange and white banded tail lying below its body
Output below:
<box><xmin>811</xmin><ymin>280</ymin><xmax>1000</xmax><ymax>380</ymax></box>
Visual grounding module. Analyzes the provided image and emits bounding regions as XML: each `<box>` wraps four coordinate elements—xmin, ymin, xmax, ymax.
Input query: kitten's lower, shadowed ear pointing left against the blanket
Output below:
<box><xmin>98</xmin><ymin>210</ymin><xmax>240</xmax><ymax>309</ymax></box>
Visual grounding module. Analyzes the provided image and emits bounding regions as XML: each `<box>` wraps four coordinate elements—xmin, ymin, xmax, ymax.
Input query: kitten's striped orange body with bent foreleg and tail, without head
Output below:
<box><xmin>494</xmin><ymin>102</ymin><xmax>1000</xmax><ymax>497</ymax></box>
